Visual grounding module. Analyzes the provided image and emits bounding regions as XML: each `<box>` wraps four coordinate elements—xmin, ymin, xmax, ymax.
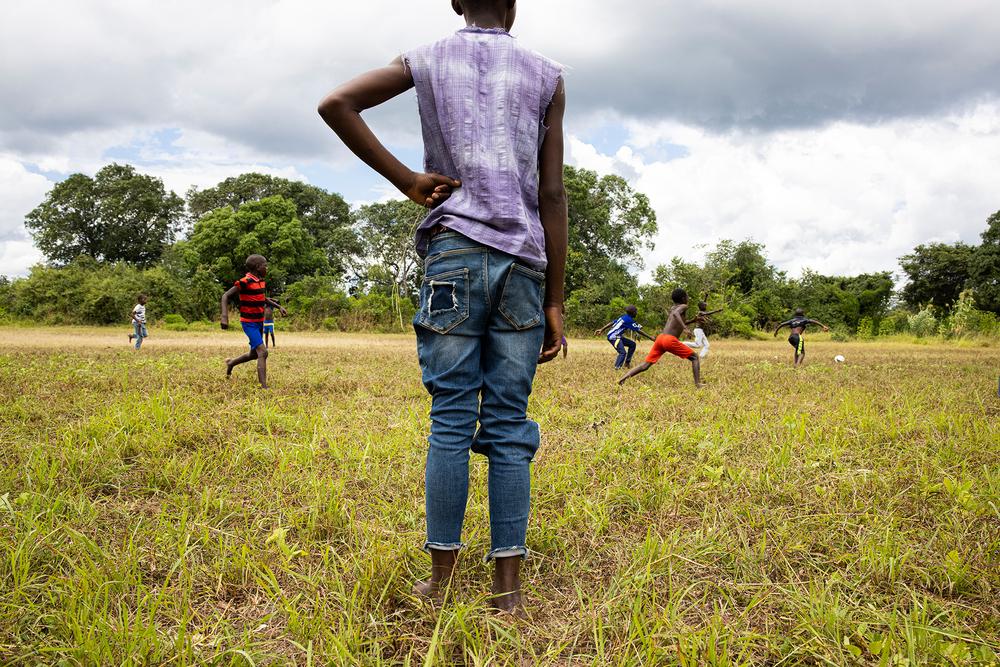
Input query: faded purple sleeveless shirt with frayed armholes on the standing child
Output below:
<box><xmin>403</xmin><ymin>27</ymin><xmax>562</xmax><ymax>271</ymax></box>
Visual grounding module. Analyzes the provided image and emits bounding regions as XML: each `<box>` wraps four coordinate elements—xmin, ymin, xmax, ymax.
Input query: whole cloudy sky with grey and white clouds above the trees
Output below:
<box><xmin>0</xmin><ymin>0</ymin><xmax>1000</xmax><ymax>276</ymax></box>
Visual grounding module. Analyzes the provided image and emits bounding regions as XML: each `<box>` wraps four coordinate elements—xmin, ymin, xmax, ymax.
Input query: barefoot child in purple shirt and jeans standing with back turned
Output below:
<box><xmin>319</xmin><ymin>0</ymin><xmax>567</xmax><ymax>613</ymax></box>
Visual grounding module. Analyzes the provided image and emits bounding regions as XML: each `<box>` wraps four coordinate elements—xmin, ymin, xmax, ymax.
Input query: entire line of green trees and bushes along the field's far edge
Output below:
<box><xmin>0</xmin><ymin>164</ymin><xmax>1000</xmax><ymax>337</ymax></box>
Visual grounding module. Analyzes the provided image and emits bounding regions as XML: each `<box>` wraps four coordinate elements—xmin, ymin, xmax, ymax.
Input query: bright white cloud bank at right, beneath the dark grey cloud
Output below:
<box><xmin>568</xmin><ymin>104</ymin><xmax>1000</xmax><ymax>275</ymax></box>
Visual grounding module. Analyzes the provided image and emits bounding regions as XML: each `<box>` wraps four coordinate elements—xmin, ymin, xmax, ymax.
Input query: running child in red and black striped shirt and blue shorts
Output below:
<box><xmin>220</xmin><ymin>255</ymin><xmax>288</xmax><ymax>389</ymax></box>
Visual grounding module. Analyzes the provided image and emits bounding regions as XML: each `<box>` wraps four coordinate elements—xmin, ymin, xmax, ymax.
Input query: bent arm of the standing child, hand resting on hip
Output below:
<box><xmin>319</xmin><ymin>57</ymin><xmax>461</xmax><ymax>207</ymax></box>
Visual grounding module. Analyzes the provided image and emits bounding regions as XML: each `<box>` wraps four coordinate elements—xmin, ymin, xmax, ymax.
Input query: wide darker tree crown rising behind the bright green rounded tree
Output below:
<box><xmin>187</xmin><ymin>172</ymin><xmax>359</xmax><ymax>273</ymax></box>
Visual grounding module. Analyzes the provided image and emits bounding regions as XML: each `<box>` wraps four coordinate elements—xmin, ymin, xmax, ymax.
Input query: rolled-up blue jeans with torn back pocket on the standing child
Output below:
<box><xmin>413</xmin><ymin>232</ymin><xmax>545</xmax><ymax>560</ymax></box>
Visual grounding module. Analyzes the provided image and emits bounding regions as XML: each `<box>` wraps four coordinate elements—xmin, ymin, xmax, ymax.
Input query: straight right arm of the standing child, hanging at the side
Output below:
<box><xmin>538</xmin><ymin>79</ymin><xmax>569</xmax><ymax>363</ymax></box>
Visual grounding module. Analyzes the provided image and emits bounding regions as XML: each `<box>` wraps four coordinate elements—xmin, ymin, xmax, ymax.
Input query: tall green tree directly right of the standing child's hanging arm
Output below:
<box><xmin>564</xmin><ymin>166</ymin><xmax>657</xmax><ymax>294</ymax></box>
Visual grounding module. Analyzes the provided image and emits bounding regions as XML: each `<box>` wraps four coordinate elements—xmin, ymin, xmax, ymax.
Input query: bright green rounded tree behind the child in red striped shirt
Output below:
<box><xmin>177</xmin><ymin>196</ymin><xmax>329</xmax><ymax>292</ymax></box>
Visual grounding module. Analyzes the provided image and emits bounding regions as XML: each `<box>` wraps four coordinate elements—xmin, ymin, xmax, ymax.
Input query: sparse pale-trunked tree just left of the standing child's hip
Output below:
<box><xmin>354</xmin><ymin>199</ymin><xmax>427</xmax><ymax>328</ymax></box>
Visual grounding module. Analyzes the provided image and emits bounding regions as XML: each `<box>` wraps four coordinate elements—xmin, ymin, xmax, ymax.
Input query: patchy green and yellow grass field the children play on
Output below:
<box><xmin>0</xmin><ymin>328</ymin><xmax>1000</xmax><ymax>665</ymax></box>
